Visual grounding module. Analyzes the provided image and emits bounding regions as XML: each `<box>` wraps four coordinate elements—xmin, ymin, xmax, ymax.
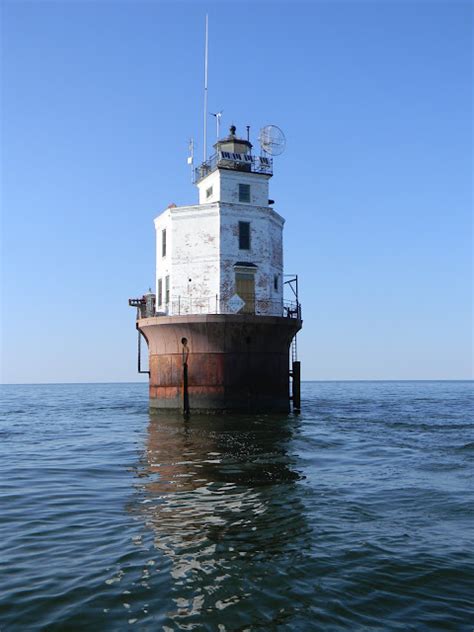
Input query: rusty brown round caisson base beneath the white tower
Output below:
<box><xmin>137</xmin><ymin>314</ymin><xmax>302</xmax><ymax>414</ymax></box>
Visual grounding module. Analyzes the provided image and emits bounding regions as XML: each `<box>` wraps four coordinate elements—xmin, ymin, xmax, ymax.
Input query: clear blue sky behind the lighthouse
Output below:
<box><xmin>0</xmin><ymin>0</ymin><xmax>473</xmax><ymax>383</ymax></box>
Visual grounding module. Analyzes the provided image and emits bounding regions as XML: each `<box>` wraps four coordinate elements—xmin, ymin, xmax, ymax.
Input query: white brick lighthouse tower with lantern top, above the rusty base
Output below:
<box><xmin>155</xmin><ymin>127</ymin><xmax>285</xmax><ymax>316</ymax></box>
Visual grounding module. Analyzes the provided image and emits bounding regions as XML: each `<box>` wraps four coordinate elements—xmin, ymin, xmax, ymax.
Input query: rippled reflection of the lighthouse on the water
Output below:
<box><xmin>133</xmin><ymin>415</ymin><xmax>309</xmax><ymax>630</ymax></box>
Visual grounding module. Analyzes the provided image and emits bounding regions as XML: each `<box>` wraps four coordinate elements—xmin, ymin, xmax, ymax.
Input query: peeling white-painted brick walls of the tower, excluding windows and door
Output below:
<box><xmin>155</xmin><ymin>169</ymin><xmax>284</xmax><ymax>315</ymax></box>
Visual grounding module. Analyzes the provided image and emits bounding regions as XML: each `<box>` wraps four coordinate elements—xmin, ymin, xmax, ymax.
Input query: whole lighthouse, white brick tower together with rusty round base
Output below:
<box><xmin>129</xmin><ymin>126</ymin><xmax>302</xmax><ymax>414</ymax></box>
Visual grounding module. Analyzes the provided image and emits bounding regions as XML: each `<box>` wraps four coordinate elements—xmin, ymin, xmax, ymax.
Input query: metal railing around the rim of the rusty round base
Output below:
<box><xmin>129</xmin><ymin>294</ymin><xmax>301</xmax><ymax>320</ymax></box>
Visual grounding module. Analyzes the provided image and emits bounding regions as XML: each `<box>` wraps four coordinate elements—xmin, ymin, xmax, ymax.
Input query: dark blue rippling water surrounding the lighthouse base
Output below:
<box><xmin>0</xmin><ymin>382</ymin><xmax>474</xmax><ymax>632</ymax></box>
